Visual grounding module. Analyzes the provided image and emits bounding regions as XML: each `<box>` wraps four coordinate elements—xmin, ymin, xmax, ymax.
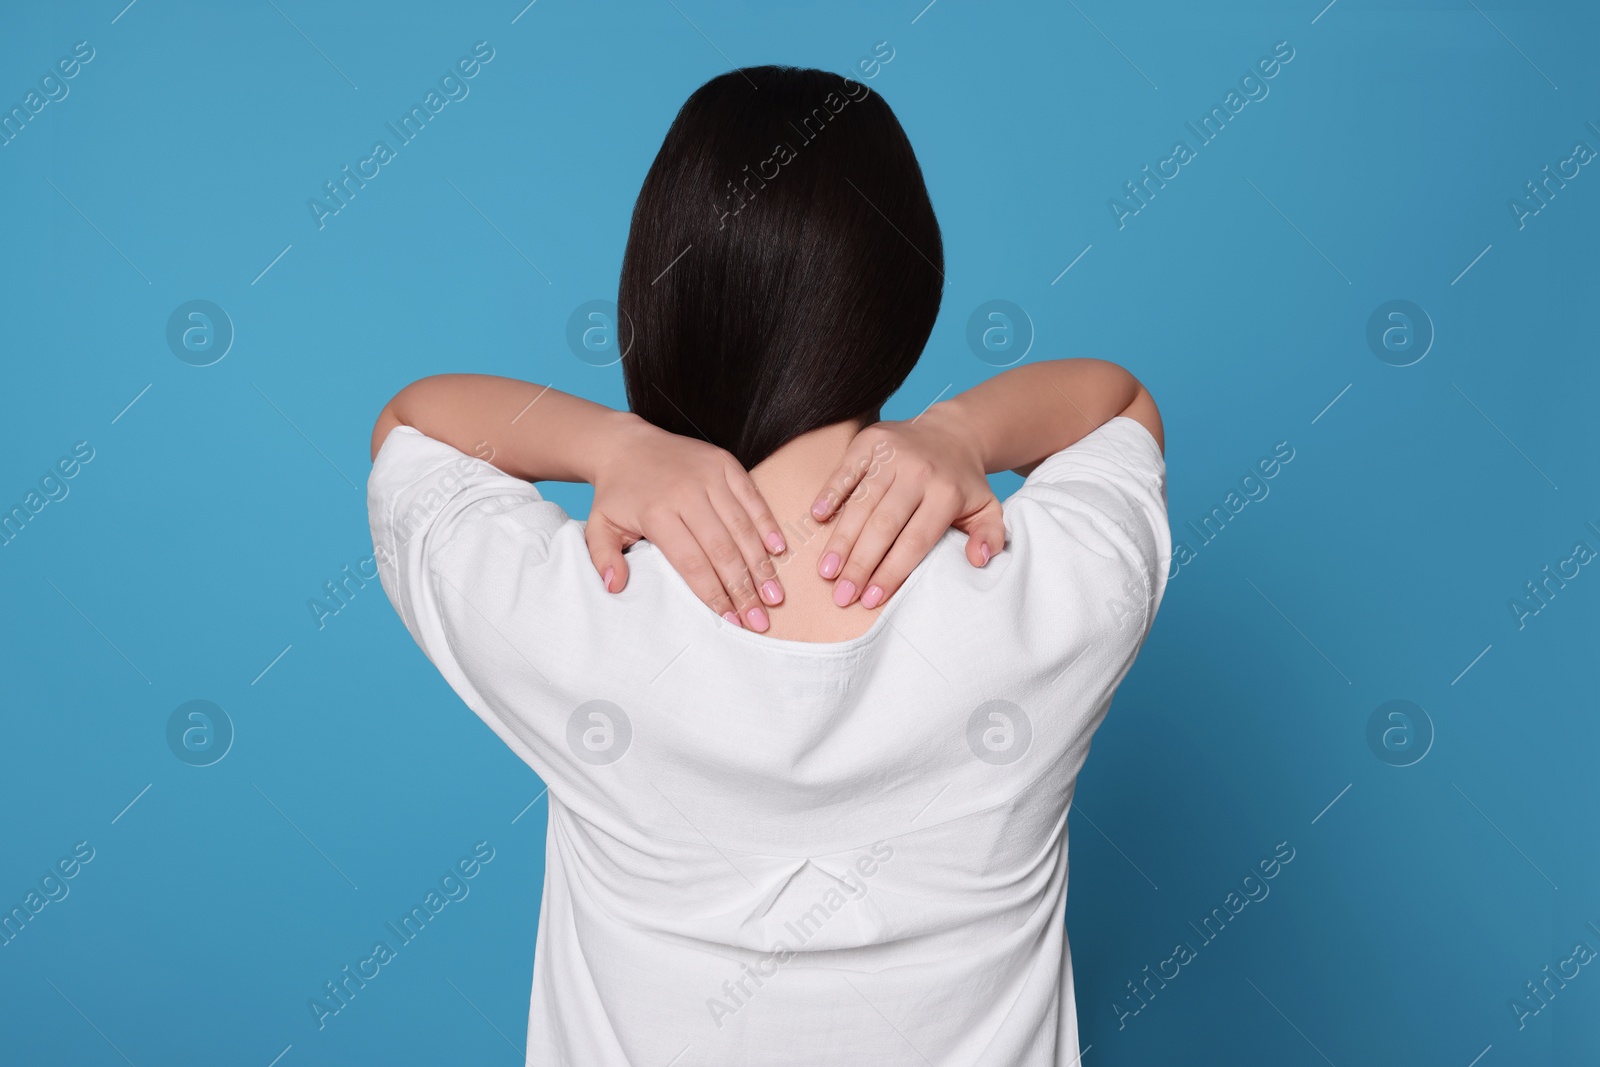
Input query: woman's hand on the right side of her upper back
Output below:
<box><xmin>811</xmin><ymin>405</ymin><xmax>1005</xmax><ymax>608</ymax></box>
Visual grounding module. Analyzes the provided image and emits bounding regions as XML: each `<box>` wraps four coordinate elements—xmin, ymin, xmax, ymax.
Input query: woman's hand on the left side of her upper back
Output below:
<box><xmin>584</xmin><ymin>413</ymin><xmax>784</xmax><ymax>632</ymax></box>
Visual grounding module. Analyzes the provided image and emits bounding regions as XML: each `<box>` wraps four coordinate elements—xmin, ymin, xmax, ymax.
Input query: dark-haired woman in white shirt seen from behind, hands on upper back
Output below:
<box><xmin>368</xmin><ymin>67</ymin><xmax>1171</xmax><ymax>1067</ymax></box>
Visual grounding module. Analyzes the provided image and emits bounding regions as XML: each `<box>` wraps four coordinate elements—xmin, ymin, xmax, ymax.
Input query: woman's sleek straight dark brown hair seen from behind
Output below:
<box><xmin>618</xmin><ymin>67</ymin><xmax>944</xmax><ymax>469</ymax></box>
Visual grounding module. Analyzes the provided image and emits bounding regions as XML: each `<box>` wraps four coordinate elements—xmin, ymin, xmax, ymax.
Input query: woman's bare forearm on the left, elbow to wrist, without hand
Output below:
<box><xmin>373</xmin><ymin>374</ymin><xmax>638</xmax><ymax>483</ymax></box>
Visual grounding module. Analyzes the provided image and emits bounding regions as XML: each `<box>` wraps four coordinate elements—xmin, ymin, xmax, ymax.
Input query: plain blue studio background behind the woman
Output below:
<box><xmin>0</xmin><ymin>0</ymin><xmax>1600</xmax><ymax>1067</ymax></box>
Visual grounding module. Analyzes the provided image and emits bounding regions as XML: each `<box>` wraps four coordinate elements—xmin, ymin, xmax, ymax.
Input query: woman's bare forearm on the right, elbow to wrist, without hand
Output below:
<box><xmin>923</xmin><ymin>360</ymin><xmax>1162</xmax><ymax>475</ymax></box>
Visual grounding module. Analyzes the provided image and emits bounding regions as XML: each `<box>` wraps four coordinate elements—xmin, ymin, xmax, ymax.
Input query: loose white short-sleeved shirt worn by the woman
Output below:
<box><xmin>368</xmin><ymin>418</ymin><xmax>1171</xmax><ymax>1067</ymax></box>
